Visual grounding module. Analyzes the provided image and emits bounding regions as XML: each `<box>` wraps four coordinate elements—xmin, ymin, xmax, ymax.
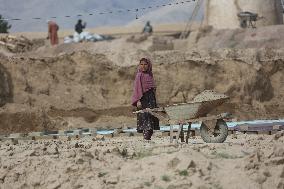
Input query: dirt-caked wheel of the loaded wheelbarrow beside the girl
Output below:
<box><xmin>200</xmin><ymin>119</ymin><xmax>228</xmax><ymax>143</ymax></box>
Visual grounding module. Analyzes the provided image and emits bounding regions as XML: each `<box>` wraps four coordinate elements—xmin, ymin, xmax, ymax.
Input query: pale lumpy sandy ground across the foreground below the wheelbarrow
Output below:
<box><xmin>0</xmin><ymin>132</ymin><xmax>284</xmax><ymax>189</ymax></box>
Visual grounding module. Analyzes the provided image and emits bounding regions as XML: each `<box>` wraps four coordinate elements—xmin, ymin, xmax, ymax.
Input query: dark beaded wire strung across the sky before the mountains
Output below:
<box><xmin>0</xmin><ymin>0</ymin><xmax>196</xmax><ymax>21</ymax></box>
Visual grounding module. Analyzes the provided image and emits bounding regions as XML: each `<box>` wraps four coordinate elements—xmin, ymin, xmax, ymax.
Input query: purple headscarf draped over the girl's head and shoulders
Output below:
<box><xmin>132</xmin><ymin>58</ymin><xmax>156</xmax><ymax>106</ymax></box>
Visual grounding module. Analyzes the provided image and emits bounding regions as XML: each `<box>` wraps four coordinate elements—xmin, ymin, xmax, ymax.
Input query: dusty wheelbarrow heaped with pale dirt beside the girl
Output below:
<box><xmin>134</xmin><ymin>90</ymin><xmax>231</xmax><ymax>143</ymax></box>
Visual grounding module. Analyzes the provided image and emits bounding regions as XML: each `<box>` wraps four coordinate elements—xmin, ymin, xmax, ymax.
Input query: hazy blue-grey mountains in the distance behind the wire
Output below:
<box><xmin>0</xmin><ymin>0</ymin><xmax>204</xmax><ymax>32</ymax></box>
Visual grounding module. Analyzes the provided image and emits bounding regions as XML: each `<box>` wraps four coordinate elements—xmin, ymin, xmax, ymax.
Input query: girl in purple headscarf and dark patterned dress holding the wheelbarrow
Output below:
<box><xmin>132</xmin><ymin>58</ymin><xmax>160</xmax><ymax>140</ymax></box>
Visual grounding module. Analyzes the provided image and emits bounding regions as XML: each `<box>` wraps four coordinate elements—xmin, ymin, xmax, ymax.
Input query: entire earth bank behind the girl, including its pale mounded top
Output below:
<box><xmin>0</xmin><ymin>26</ymin><xmax>284</xmax><ymax>133</ymax></box>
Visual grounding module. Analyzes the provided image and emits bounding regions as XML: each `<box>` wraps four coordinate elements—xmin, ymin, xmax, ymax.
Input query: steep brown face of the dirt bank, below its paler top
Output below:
<box><xmin>0</xmin><ymin>49</ymin><xmax>284</xmax><ymax>134</ymax></box>
